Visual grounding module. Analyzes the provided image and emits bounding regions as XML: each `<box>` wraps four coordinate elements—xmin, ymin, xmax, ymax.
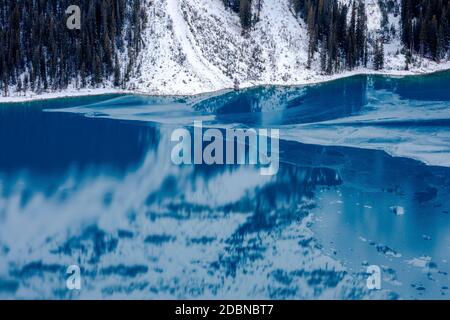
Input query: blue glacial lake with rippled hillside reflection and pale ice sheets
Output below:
<box><xmin>0</xmin><ymin>73</ymin><xmax>450</xmax><ymax>299</ymax></box>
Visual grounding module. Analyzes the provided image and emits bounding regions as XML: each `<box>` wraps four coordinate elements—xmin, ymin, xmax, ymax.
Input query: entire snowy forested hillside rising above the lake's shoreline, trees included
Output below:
<box><xmin>0</xmin><ymin>0</ymin><xmax>450</xmax><ymax>96</ymax></box>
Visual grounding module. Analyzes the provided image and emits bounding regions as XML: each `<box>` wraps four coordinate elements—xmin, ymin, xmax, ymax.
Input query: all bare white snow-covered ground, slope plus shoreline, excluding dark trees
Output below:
<box><xmin>0</xmin><ymin>0</ymin><xmax>450</xmax><ymax>102</ymax></box>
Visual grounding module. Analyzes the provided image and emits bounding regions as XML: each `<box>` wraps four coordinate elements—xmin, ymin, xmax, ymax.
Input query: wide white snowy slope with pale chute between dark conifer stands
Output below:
<box><xmin>132</xmin><ymin>0</ymin><xmax>309</xmax><ymax>94</ymax></box>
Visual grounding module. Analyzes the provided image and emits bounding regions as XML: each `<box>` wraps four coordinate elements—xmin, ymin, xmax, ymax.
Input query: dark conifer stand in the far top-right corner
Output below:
<box><xmin>401</xmin><ymin>0</ymin><xmax>450</xmax><ymax>61</ymax></box>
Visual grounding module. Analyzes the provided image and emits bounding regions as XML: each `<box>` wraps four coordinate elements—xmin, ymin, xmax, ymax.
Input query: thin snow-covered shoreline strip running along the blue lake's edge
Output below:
<box><xmin>0</xmin><ymin>61</ymin><xmax>450</xmax><ymax>104</ymax></box>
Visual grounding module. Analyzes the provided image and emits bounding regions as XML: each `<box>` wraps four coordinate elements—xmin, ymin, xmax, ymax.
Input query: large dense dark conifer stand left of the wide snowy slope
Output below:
<box><xmin>0</xmin><ymin>0</ymin><xmax>146</xmax><ymax>95</ymax></box>
